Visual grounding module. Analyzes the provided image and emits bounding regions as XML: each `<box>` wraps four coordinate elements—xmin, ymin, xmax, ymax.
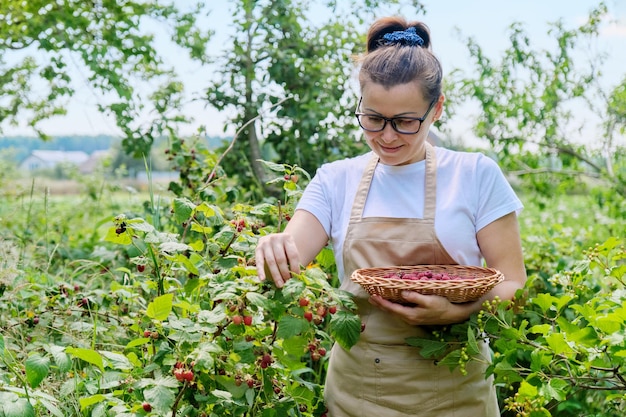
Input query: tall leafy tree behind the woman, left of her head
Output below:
<box><xmin>206</xmin><ymin>0</ymin><xmax>420</xmax><ymax>195</ymax></box>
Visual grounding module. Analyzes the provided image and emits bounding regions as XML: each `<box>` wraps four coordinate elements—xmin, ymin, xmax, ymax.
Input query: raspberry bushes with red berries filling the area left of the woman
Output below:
<box><xmin>0</xmin><ymin>141</ymin><xmax>361</xmax><ymax>417</ymax></box>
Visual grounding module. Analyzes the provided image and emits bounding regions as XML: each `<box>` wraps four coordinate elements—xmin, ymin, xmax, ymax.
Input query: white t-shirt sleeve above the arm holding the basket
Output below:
<box><xmin>475</xmin><ymin>155</ymin><xmax>523</xmax><ymax>232</ymax></box>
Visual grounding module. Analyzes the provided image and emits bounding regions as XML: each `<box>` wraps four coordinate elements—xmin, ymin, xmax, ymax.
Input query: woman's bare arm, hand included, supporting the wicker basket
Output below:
<box><xmin>370</xmin><ymin>212</ymin><xmax>526</xmax><ymax>325</ymax></box>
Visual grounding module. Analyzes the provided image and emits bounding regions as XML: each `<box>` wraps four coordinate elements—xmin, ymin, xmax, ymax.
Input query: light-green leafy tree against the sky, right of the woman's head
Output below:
<box><xmin>442</xmin><ymin>4</ymin><xmax>626</xmax><ymax>197</ymax></box>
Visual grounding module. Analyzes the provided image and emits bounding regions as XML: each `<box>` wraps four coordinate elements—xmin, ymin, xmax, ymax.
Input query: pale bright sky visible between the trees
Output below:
<box><xmin>2</xmin><ymin>0</ymin><xmax>626</xmax><ymax>143</ymax></box>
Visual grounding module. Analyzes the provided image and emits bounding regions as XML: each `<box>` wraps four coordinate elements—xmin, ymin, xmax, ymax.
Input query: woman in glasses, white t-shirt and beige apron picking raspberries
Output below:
<box><xmin>256</xmin><ymin>17</ymin><xmax>526</xmax><ymax>417</ymax></box>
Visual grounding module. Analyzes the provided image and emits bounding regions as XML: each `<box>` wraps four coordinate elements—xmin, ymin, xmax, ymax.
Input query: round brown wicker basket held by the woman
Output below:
<box><xmin>351</xmin><ymin>265</ymin><xmax>504</xmax><ymax>303</ymax></box>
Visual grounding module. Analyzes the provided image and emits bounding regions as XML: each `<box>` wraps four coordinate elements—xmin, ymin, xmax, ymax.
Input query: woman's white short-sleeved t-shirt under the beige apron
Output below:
<box><xmin>296</xmin><ymin>148</ymin><xmax>522</xmax><ymax>279</ymax></box>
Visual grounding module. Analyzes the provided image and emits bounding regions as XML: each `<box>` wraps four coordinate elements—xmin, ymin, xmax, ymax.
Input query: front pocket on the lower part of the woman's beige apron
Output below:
<box><xmin>371</xmin><ymin>346</ymin><xmax>438</xmax><ymax>414</ymax></box>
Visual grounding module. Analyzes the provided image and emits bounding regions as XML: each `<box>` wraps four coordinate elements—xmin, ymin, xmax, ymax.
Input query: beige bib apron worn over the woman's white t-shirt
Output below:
<box><xmin>324</xmin><ymin>144</ymin><xmax>500</xmax><ymax>417</ymax></box>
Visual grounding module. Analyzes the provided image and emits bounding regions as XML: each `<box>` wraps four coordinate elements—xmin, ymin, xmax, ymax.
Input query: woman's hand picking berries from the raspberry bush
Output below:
<box><xmin>254</xmin><ymin>232</ymin><xmax>300</xmax><ymax>288</ymax></box>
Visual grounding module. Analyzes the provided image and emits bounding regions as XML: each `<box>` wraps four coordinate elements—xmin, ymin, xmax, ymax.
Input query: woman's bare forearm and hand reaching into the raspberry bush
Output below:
<box><xmin>255</xmin><ymin>210</ymin><xmax>328</xmax><ymax>288</ymax></box>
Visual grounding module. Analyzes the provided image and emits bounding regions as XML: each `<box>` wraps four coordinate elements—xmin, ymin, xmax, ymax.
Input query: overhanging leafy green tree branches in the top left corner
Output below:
<box><xmin>0</xmin><ymin>0</ymin><xmax>211</xmax><ymax>156</ymax></box>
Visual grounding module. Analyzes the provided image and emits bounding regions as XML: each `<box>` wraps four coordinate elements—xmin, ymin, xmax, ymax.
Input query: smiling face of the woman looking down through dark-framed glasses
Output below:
<box><xmin>357</xmin><ymin>82</ymin><xmax>444</xmax><ymax>165</ymax></box>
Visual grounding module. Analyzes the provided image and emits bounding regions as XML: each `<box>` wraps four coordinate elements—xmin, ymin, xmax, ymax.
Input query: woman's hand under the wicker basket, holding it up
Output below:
<box><xmin>369</xmin><ymin>291</ymin><xmax>474</xmax><ymax>326</ymax></box>
